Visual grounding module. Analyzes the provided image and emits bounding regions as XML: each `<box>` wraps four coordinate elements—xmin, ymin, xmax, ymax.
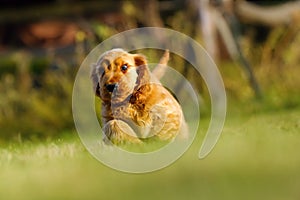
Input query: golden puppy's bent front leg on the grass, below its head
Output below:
<box><xmin>103</xmin><ymin>119</ymin><xmax>142</xmax><ymax>144</ymax></box>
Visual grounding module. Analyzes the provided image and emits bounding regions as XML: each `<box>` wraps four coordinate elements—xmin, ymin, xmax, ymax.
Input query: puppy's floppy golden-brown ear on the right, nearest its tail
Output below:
<box><xmin>134</xmin><ymin>54</ymin><xmax>150</xmax><ymax>90</ymax></box>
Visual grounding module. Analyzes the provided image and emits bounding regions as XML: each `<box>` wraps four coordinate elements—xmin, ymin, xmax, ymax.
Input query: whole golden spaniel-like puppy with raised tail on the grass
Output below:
<box><xmin>91</xmin><ymin>49</ymin><xmax>187</xmax><ymax>144</ymax></box>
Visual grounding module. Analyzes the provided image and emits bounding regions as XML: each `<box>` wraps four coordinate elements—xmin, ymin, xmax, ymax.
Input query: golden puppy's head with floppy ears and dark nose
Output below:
<box><xmin>91</xmin><ymin>49</ymin><xmax>150</xmax><ymax>101</ymax></box>
